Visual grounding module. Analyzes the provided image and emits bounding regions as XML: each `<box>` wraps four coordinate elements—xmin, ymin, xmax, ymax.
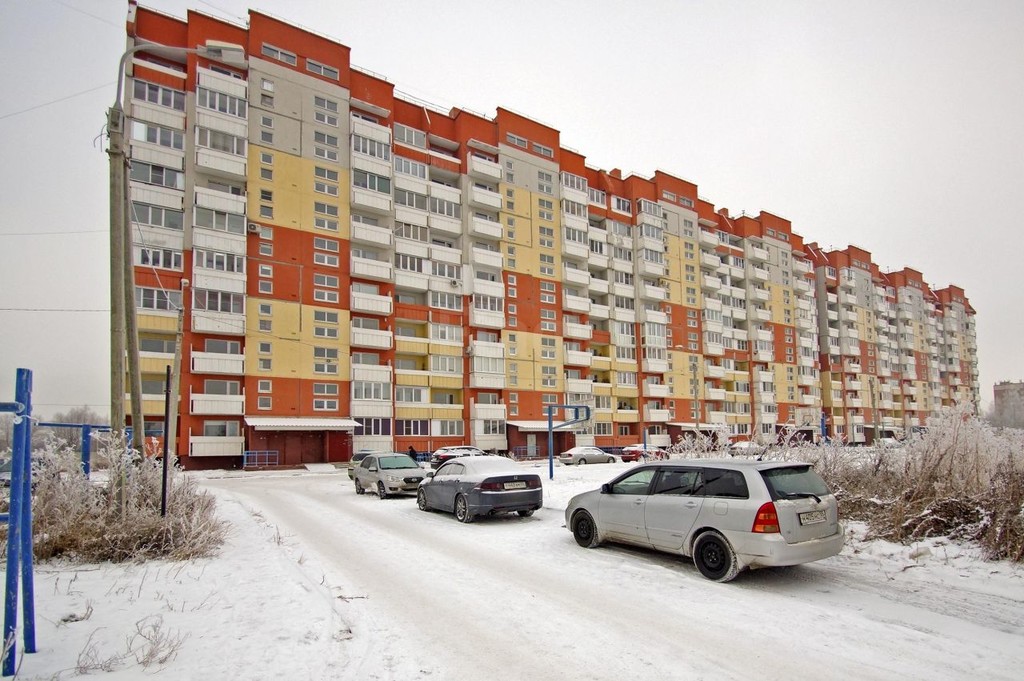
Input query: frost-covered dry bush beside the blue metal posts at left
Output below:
<box><xmin>0</xmin><ymin>438</ymin><xmax>227</xmax><ymax>562</ymax></box>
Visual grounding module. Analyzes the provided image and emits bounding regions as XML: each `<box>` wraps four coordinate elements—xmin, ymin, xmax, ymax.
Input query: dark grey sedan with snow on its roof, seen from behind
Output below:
<box><xmin>416</xmin><ymin>456</ymin><xmax>544</xmax><ymax>522</ymax></box>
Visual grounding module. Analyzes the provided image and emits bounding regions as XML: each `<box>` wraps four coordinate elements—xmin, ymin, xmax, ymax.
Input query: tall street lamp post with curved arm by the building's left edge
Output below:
<box><xmin>106</xmin><ymin>40</ymin><xmax>246</xmax><ymax>430</ymax></box>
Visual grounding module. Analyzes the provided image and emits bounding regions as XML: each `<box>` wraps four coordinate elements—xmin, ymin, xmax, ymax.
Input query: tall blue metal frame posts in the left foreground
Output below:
<box><xmin>0</xmin><ymin>369</ymin><xmax>36</xmax><ymax>676</ymax></box>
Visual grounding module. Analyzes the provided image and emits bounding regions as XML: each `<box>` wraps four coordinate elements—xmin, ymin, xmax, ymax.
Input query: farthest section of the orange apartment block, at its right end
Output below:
<box><xmin>809</xmin><ymin>244</ymin><xmax>979</xmax><ymax>443</ymax></box>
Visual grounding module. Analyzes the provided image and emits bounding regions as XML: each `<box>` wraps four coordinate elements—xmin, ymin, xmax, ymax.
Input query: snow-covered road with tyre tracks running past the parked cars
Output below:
<box><xmin>203</xmin><ymin>464</ymin><xmax>1024</xmax><ymax>679</ymax></box>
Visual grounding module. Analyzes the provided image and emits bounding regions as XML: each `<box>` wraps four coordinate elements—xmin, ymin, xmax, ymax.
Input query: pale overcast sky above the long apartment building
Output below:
<box><xmin>0</xmin><ymin>0</ymin><xmax>1024</xmax><ymax>416</ymax></box>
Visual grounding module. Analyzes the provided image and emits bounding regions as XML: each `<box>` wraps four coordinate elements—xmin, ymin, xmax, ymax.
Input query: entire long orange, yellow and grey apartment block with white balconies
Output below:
<box><xmin>124</xmin><ymin>4</ymin><xmax>977</xmax><ymax>468</ymax></box>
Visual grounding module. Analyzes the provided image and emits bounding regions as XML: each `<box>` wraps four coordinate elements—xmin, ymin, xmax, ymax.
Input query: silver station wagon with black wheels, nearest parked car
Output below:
<box><xmin>565</xmin><ymin>459</ymin><xmax>845</xmax><ymax>582</ymax></box>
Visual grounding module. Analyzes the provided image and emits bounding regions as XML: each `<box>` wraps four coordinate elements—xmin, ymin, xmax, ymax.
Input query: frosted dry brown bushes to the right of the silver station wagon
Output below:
<box><xmin>794</xmin><ymin>407</ymin><xmax>1024</xmax><ymax>562</ymax></box>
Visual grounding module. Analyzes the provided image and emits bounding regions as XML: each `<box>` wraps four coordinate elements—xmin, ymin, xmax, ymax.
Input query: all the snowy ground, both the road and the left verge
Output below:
<box><xmin>6</xmin><ymin>464</ymin><xmax>1024</xmax><ymax>681</ymax></box>
